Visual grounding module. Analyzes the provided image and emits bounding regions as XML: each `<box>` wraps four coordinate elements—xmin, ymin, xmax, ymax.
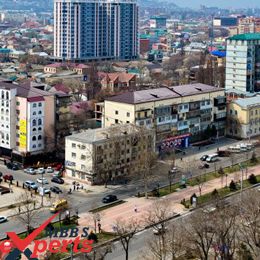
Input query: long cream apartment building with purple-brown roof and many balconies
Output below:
<box><xmin>100</xmin><ymin>84</ymin><xmax>226</xmax><ymax>150</ymax></box>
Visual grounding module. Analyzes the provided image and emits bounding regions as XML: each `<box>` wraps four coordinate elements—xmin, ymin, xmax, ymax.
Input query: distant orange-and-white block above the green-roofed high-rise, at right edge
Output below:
<box><xmin>238</xmin><ymin>17</ymin><xmax>260</xmax><ymax>34</ymax></box>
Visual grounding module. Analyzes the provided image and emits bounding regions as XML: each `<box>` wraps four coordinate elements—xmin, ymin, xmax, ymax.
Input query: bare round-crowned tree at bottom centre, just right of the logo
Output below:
<box><xmin>115</xmin><ymin>219</ymin><xmax>139</xmax><ymax>260</ymax></box>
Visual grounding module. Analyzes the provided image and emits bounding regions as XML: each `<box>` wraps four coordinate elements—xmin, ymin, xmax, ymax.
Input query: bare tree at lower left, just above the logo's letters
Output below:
<box><xmin>15</xmin><ymin>190</ymin><xmax>39</xmax><ymax>234</ymax></box>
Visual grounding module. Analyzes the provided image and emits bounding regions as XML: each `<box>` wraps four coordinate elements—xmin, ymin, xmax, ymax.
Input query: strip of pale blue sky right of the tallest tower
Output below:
<box><xmin>173</xmin><ymin>0</ymin><xmax>260</xmax><ymax>8</ymax></box>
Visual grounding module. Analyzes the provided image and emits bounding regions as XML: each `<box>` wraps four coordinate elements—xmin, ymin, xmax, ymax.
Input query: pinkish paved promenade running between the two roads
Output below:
<box><xmin>79</xmin><ymin>166</ymin><xmax>260</xmax><ymax>232</ymax></box>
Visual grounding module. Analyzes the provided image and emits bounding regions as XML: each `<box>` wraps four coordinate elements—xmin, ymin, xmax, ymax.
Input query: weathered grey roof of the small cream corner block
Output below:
<box><xmin>66</xmin><ymin>124</ymin><xmax>142</xmax><ymax>144</ymax></box>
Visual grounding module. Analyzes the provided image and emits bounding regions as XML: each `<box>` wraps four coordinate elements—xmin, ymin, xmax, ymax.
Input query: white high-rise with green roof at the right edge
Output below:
<box><xmin>226</xmin><ymin>33</ymin><xmax>260</xmax><ymax>93</ymax></box>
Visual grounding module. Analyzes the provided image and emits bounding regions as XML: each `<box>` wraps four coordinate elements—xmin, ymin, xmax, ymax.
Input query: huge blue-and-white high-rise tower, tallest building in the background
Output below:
<box><xmin>54</xmin><ymin>0</ymin><xmax>138</xmax><ymax>61</ymax></box>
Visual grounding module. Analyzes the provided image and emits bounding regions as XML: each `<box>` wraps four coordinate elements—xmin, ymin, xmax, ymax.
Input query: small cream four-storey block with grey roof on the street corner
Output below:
<box><xmin>65</xmin><ymin>124</ymin><xmax>154</xmax><ymax>184</ymax></box>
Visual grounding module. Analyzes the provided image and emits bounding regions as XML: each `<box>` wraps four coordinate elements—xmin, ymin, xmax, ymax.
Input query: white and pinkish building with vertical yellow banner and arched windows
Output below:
<box><xmin>0</xmin><ymin>82</ymin><xmax>55</xmax><ymax>160</ymax></box>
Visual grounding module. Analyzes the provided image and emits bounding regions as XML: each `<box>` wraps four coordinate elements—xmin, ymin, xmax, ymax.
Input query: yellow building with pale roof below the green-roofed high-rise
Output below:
<box><xmin>227</xmin><ymin>96</ymin><xmax>260</xmax><ymax>138</ymax></box>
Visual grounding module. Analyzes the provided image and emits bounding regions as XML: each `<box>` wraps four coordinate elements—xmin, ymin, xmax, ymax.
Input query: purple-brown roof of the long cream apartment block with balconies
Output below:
<box><xmin>106</xmin><ymin>83</ymin><xmax>224</xmax><ymax>104</ymax></box>
